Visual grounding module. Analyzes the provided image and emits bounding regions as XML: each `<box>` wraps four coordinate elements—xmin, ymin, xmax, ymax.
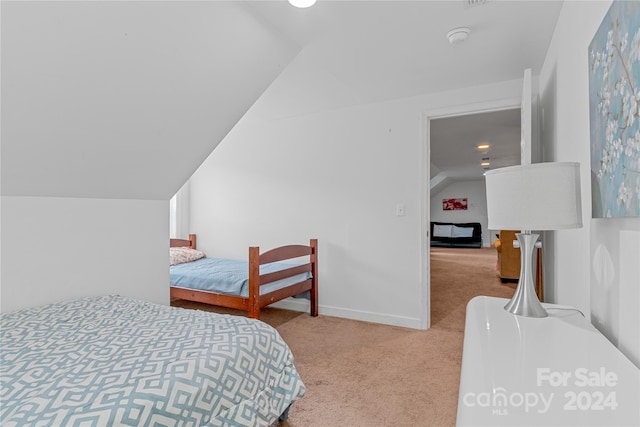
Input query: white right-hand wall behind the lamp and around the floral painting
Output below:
<box><xmin>540</xmin><ymin>2</ymin><xmax>640</xmax><ymax>366</ymax></box>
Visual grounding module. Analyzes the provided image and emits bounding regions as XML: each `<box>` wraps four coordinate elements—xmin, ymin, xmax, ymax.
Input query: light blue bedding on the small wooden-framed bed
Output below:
<box><xmin>170</xmin><ymin>258</ymin><xmax>311</xmax><ymax>297</ymax></box>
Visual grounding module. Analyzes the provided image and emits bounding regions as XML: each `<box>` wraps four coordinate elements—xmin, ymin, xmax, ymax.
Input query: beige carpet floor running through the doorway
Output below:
<box><xmin>174</xmin><ymin>248</ymin><xmax>515</xmax><ymax>427</ymax></box>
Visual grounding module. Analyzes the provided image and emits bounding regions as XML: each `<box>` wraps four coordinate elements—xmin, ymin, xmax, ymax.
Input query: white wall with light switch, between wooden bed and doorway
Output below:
<box><xmin>190</xmin><ymin>80</ymin><xmax>522</xmax><ymax>328</ymax></box>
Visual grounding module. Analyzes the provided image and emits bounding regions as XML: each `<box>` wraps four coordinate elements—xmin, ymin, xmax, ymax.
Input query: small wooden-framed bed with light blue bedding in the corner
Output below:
<box><xmin>170</xmin><ymin>234</ymin><xmax>318</xmax><ymax>319</ymax></box>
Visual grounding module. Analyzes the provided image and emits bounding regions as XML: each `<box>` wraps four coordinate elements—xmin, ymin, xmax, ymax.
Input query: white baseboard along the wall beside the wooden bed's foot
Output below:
<box><xmin>271</xmin><ymin>298</ymin><xmax>423</xmax><ymax>329</ymax></box>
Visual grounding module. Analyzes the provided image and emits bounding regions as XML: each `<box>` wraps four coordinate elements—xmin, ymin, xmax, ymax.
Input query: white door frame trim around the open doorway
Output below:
<box><xmin>420</xmin><ymin>97</ymin><xmax>522</xmax><ymax>329</ymax></box>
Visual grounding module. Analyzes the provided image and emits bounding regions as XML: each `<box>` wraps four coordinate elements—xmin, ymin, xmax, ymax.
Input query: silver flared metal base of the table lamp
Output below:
<box><xmin>504</xmin><ymin>232</ymin><xmax>549</xmax><ymax>317</ymax></box>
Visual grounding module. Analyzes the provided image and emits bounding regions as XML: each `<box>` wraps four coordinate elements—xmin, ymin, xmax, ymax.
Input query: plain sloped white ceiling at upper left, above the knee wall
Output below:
<box><xmin>1</xmin><ymin>1</ymin><xmax>299</xmax><ymax>199</ymax></box>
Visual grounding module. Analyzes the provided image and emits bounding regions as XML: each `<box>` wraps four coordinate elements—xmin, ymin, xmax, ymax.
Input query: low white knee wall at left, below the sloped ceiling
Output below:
<box><xmin>0</xmin><ymin>196</ymin><xmax>169</xmax><ymax>313</ymax></box>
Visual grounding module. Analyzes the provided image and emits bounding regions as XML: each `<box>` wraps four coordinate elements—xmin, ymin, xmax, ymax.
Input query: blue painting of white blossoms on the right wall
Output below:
<box><xmin>589</xmin><ymin>1</ymin><xmax>640</xmax><ymax>218</ymax></box>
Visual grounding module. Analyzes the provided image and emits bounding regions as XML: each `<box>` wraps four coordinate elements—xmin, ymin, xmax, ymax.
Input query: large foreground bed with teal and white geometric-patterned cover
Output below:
<box><xmin>0</xmin><ymin>296</ymin><xmax>305</xmax><ymax>426</ymax></box>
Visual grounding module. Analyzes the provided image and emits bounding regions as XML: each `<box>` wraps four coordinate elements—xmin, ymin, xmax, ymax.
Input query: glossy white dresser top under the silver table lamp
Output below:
<box><xmin>457</xmin><ymin>297</ymin><xmax>640</xmax><ymax>426</ymax></box>
